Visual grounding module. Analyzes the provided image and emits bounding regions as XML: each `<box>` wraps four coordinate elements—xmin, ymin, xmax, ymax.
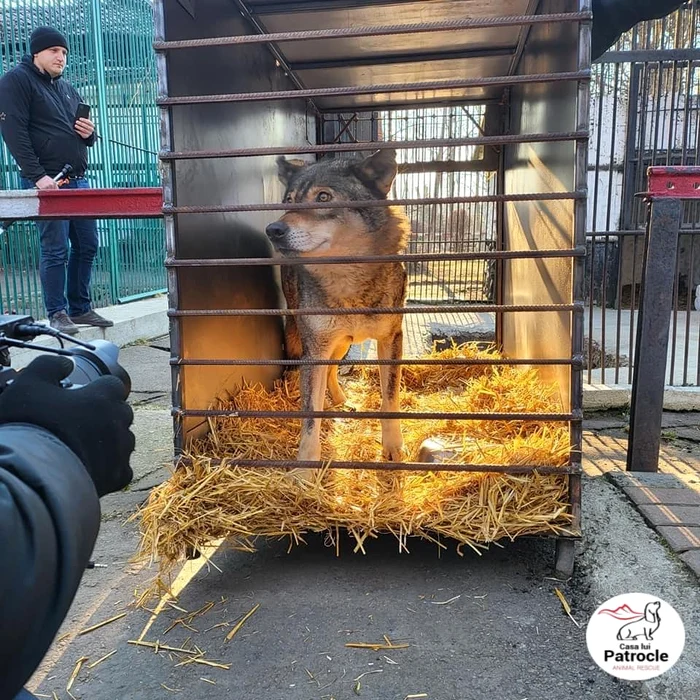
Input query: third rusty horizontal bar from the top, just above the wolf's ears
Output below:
<box><xmin>158</xmin><ymin>130</ymin><xmax>588</xmax><ymax>161</ymax></box>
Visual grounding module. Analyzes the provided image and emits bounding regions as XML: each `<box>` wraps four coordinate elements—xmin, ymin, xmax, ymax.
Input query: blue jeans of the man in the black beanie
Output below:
<box><xmin>22</xmin><ymin>178</ymin><xmax>97</xmax><ymax>318</ymax></box>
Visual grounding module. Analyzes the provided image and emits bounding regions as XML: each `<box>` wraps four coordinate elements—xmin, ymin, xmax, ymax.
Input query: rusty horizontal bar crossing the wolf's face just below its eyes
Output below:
<box><xmin>163</xmin><ymin>191</ymin><xmax>586</xmax><ymax>214</ymax></box>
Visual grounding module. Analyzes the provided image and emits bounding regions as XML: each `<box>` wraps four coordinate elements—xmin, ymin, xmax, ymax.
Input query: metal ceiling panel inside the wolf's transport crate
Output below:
<box><xmin>238</xmin><ymin>0</ymin><xmax>538</xmax><ymax>111</ymax></box>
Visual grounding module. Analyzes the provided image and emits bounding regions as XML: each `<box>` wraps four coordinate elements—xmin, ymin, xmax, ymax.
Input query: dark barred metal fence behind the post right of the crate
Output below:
<box><xmin>585</xmin><ymin>4</ymin><xmax>700</xmax><ymax>386</ymax></box>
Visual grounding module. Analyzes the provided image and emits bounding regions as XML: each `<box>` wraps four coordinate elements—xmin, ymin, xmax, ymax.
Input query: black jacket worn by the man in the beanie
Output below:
<box><xmin>0</xmin><ymin>56</ymin><xmax>95</xmax><ymax>182</ymax></box>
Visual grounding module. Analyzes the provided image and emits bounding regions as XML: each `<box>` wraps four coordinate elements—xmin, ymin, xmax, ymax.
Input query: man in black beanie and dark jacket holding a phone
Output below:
<box><xmin>0</xmin><ymin>27</ymin><xmax>114</xmax><ymax>334</ymax></box>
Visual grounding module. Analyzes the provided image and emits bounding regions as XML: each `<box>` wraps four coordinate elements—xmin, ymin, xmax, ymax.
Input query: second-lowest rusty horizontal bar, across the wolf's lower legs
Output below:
<box><xmin>171</xmin><ymin>408</ymin><xmax>583</xmax><ymax>423</ymax></box>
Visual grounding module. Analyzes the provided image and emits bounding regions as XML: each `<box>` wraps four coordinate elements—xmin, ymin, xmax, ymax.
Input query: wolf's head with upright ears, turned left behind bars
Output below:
<box><xmin>267</xmin><ymin>149</ymin><xmax>405</xmax><ymax>257</ymax></box>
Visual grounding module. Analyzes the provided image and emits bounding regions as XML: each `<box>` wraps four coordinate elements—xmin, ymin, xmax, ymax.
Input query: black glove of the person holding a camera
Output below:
<box><xmin>0</xmin><ymin>355</ymin><xmax>135</xmax><ymax>497</ymax></box>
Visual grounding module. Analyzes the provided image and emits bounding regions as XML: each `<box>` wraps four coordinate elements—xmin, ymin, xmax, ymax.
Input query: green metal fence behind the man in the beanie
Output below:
<box><xmin>0</xmin><ymin>0</ymin><xmax>166</xmax><ymax>318</ymax></box>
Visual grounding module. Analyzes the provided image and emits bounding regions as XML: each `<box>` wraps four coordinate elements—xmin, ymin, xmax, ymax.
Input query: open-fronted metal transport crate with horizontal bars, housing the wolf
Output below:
<box><xmin>154</xmin><ymin>0</ymin><xmax>591</xmax><ymax>574</ymax></box>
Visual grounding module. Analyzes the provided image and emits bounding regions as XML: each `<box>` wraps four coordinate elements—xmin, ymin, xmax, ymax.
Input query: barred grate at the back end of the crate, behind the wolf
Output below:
<box><xmin>322</xmin><ymin>104</ymin><xmax>498</xmax><ymax>303</ymax></box>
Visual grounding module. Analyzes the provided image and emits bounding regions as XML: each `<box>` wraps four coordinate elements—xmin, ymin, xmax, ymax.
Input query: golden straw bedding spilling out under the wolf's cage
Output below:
<box><xmin>139</xmin><ymin>345</ymin><xmax>570</xmax><ymax>573</ymax></box>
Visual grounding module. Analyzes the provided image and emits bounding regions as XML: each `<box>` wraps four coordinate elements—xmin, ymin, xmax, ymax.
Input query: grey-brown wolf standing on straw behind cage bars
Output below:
<box><xmin>266</xmin><ymin>149</ymin><xmax>410</xmax><ymax>478</ymax></box>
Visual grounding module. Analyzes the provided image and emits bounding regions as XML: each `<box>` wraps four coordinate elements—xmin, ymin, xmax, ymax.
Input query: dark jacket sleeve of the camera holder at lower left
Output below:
<box><xmin>0</xmin><ymin>423</ymin><xmax>100</xmax><ymax>700</ymax></box>
